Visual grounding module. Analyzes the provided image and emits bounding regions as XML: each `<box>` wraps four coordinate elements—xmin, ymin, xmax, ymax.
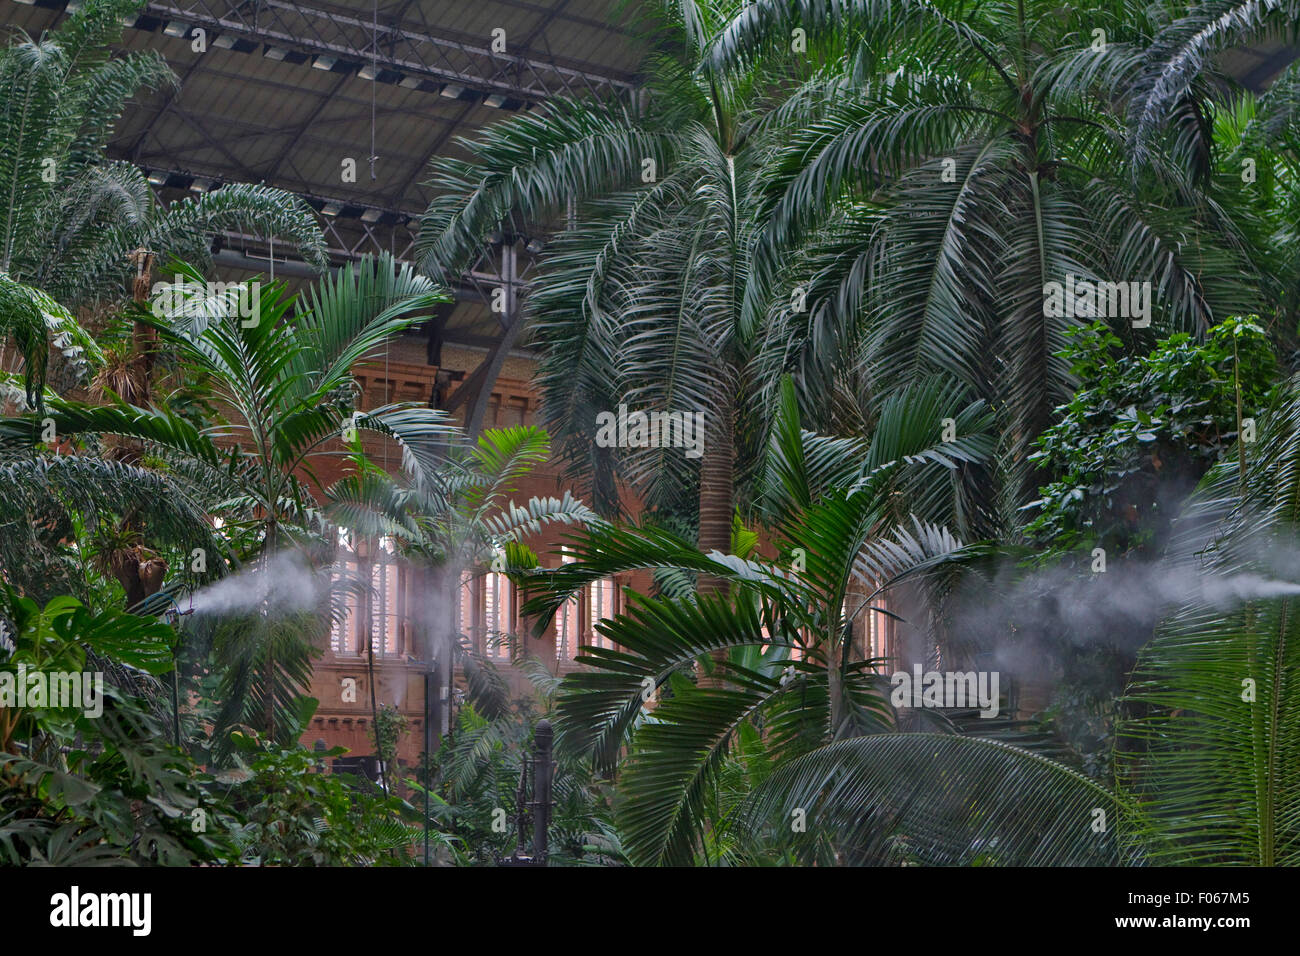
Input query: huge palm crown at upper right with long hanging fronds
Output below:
<box><xmin>709</xmin><ymin>0</ymin><xmax>1262</xmax><ymax>512</ymax></box>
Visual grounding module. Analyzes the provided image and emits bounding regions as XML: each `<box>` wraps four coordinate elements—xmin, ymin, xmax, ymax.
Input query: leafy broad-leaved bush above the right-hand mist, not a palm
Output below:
<box><xmin>1024</xmin><ymin>319</ymin><xmax>1277</xmax><ymax>558</ymax></box>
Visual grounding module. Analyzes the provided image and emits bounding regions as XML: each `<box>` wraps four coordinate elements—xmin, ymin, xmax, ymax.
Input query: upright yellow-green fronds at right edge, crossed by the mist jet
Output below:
<box><xmin>1117</xmin><ymin>366</ymin><xmax>1300</xmax><ymax>866</ymax></box>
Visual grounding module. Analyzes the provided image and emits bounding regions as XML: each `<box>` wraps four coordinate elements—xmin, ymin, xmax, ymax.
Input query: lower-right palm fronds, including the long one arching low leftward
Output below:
<box><xmin>722</xmin><ymin>380</ymin><xmax>1300</xmax><ymax>866</ymax></box>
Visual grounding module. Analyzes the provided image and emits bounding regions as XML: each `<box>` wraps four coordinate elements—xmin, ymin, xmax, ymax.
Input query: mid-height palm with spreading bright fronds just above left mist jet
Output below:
<box><xmin>3</xmin><ymin>255</ymin><xmax>455</xmax><ymax>749</ymax></box>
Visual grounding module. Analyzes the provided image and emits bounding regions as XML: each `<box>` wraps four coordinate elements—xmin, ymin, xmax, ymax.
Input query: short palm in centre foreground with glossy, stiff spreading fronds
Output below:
<box><xmin>521</xmin><ymin>380</ymin><xmax>993</xmax><ymax>864</ymax></box>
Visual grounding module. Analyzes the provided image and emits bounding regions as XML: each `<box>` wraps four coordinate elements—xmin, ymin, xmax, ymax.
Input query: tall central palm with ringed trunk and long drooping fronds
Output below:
<box><xmin>420</xmin><ymin>0</ymin><xmax>873</xmax><ymax>582</ymax></box>
